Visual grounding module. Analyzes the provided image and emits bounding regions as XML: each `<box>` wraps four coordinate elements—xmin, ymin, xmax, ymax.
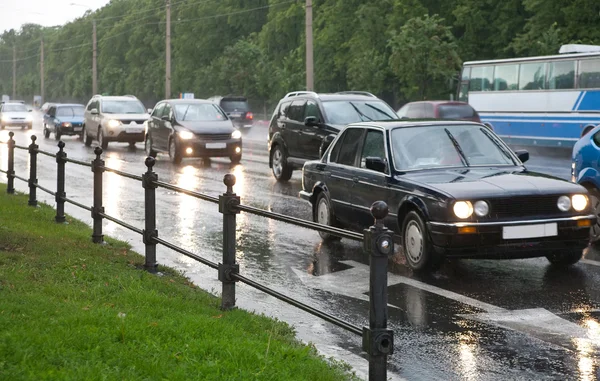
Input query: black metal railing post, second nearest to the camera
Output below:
<box><xmin>219</xmin><ymin>173</ymin><xmax>240</xmax><ymax>310</ymax></box>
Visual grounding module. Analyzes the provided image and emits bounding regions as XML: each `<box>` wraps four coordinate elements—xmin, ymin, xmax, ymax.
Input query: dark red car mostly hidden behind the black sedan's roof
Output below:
<box><xmin>397</xmin><ymin>101</ymin><xmax>481</xmax><ymax>123</ymax></box>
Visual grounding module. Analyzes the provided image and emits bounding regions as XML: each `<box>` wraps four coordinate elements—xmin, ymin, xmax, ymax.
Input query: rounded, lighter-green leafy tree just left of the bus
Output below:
<box><xmin>389</xmin><ymin>15</ymin><xmax>461</xmax><ymax>99</ymax></box>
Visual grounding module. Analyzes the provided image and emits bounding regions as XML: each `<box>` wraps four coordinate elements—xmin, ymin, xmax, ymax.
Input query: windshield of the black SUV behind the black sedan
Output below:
<box><xmin>323</xmin><ymin>101</ymin><xmax>398</xmax><ymax>125</ymax></box>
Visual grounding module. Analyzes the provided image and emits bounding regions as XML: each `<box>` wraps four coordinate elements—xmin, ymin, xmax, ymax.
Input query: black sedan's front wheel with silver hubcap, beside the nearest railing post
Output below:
<box><xmin>402</xmin><ymin>210</ymin><xmax>442</xmax><ymax>271</ymax></box>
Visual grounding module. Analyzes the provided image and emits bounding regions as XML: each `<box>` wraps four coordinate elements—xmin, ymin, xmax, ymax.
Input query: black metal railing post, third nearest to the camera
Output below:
<box><xmin>142</xmin><ymin>156</ymin><xmax>158</xmax><ymax>273</ymax></box>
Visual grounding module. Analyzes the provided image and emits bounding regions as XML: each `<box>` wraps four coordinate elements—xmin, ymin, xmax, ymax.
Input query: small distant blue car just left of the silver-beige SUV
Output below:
<box><xmin>44</xmin><ymin>104</ymin><xmax>85</xmax><ymax>140</ymax></box>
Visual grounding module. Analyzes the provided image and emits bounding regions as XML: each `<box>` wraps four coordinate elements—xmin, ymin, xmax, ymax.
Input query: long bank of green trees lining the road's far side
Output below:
<box><xmin>0</xmin><ymin>0</ymin><xmax>600</xmax><ymax>111</ymax></box>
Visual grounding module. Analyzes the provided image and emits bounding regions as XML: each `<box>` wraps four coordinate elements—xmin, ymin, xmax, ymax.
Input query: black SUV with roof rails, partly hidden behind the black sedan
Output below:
<box><xmin>268</xmin><ymin>91</ymin><xmax>398</xmax><ymax>181</ymax></box>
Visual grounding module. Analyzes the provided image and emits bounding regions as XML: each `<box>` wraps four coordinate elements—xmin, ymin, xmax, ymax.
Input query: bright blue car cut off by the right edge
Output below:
<box><xmin>571</xmin><ymin>124</ymin><xmax>600</xmax><ymax>245</ymax></box>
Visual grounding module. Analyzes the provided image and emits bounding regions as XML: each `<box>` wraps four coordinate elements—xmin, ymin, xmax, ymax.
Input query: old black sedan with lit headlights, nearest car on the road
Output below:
<box><xmin>300</xmin><ymin>121</ymin><xmax>595</xmax><ymax>270</ymax></box>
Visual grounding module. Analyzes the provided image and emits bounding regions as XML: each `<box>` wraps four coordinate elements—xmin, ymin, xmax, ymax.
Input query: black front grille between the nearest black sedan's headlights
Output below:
<box><xmin>490</xmin><ymin>195</ymin><xmax>564</xmax><ymax>218</ymax></box>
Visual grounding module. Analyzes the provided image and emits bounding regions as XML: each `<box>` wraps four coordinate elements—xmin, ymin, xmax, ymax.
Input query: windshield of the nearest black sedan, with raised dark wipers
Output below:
<box><xmin>391</xmin><ymin>125</ymin><xmax>517</xmax><ymax>170</ymax></box>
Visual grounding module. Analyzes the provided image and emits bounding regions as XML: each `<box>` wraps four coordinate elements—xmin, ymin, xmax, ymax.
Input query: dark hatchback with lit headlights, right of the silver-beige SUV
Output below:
<box><xmin>145</xmin><ymin>99</ymin><xmax>242</xmax><ymax>164</ymax></box>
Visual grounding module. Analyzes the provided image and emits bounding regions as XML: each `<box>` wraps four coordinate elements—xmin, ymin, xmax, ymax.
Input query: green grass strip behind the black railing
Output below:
<box><xmin>0</xmin><ymin>184</ymin><xmax>355</xmax><ymax>381</ymax></box>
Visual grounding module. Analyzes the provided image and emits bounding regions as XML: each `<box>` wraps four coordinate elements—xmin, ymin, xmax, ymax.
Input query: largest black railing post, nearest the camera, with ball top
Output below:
<box><xmin>363</xmin><ymin>201</ymin><xmax>394</xmax><ymax>381</ymax></box>
